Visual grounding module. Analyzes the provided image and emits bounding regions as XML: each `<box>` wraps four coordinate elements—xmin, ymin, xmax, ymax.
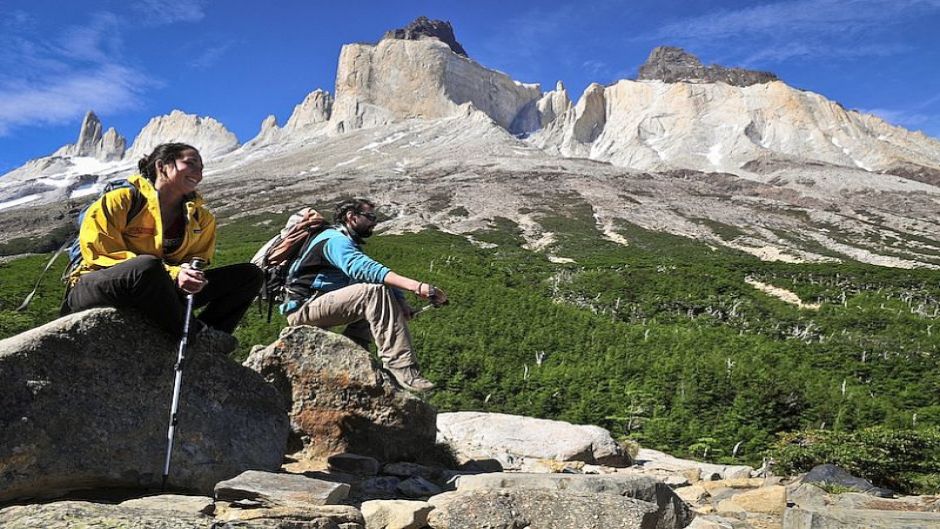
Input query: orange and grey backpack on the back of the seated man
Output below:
<box><xmin>251</xmin><ymin>208</ymin><xmax>329</xmax><ymax>323</ymax></box>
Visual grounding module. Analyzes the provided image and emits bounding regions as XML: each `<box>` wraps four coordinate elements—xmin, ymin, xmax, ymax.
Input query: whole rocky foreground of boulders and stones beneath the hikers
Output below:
<box><xmin>0</xmin><ymin>309</ymin><xmax>940</xmax><ymax>529</ymax></box>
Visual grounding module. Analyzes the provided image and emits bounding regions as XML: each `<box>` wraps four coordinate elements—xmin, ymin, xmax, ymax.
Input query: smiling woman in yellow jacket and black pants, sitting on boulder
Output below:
<box><xmin>65</xmin><ymin>143</ymin><xmax>261</xmax><ymax>336</ymax></box>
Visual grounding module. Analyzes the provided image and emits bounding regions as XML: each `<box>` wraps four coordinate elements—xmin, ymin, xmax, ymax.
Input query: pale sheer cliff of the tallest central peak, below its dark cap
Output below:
<box><xmin>330</xmin><ymin>34</ymin><xmax>542</xmax><ymax>132</ymax></box>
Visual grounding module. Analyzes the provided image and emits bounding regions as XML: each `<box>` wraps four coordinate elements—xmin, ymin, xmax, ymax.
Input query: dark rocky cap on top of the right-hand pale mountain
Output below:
<box><xmin>637</xmin><ymin>46</ymin><xmax>777</xmax><ymax>86</ymax></box>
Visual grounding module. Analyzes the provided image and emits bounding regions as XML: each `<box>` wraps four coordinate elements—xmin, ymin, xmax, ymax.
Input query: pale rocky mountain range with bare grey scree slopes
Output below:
<box><xmin>0</xmin><ymin>18</ymin><xmax>940</xmax><ymax>267</ymax></box>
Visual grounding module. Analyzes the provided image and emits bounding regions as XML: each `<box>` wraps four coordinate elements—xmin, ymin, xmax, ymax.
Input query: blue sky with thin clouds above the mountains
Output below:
<box><xmin>0</xmin><ymin>0</ymin><xmax>940</xmax><ymax>174</ymax></box>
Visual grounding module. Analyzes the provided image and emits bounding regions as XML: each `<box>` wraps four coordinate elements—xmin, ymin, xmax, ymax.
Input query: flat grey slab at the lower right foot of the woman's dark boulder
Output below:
<box><xmin>215</xmin><ymin>470</ymin><xmax>349</xmax><ymax>507</ymax></box>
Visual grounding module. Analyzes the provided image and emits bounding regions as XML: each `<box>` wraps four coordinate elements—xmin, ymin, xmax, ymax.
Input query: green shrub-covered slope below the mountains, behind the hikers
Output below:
<box><xmin>0</xmin><ymin>203</ymin><xmax>940</xmax><ymax>488</ymax></box>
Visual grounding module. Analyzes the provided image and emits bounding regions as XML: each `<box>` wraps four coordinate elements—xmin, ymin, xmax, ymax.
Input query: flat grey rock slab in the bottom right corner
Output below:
<box><xmin>783</xmin><ymin>507</ymin><xmax>940</xmax><ymax>529</ymax></box>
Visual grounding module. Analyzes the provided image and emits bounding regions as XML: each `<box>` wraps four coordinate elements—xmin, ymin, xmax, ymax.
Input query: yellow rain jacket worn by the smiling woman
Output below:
<box><xmin>69</xmin><ymin>175</ymin><xmax>215</xmax><ymax>285</ymax></box>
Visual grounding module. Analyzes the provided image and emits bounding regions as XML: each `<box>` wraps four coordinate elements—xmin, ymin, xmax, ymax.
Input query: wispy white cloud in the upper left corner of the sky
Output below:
<box><xmin>0</xmin><ymin>0</ymin><xmax>202</xmax><ymax>136</ymax></box>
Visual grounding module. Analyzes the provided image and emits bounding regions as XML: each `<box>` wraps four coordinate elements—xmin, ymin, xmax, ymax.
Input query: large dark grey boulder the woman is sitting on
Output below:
<box><xmin>0</xmin><ymin>309</ymin><xmax>289</xmax><ymax>501</ymax></box>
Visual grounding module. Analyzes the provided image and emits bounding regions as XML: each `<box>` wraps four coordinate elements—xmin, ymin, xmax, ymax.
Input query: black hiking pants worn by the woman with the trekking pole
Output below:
<box><xmin>63</xmin><ymin>255</ymin><xmax>261</xmax><ymax>336</ymax></box>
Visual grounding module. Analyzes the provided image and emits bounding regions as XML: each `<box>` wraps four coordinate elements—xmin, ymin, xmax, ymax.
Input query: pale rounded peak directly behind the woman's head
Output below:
<box><xmin>127</xmin><ymin>110</ymin><xmax>238</xmax><ymax>161</ymax></box>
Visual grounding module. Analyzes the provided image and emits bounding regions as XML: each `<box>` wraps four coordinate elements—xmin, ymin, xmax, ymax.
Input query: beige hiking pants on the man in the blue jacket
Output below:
<box><xmin>287</xmin><ymin>283</ymin><xmax>417</xmax><ymax>368</ymax></box>
